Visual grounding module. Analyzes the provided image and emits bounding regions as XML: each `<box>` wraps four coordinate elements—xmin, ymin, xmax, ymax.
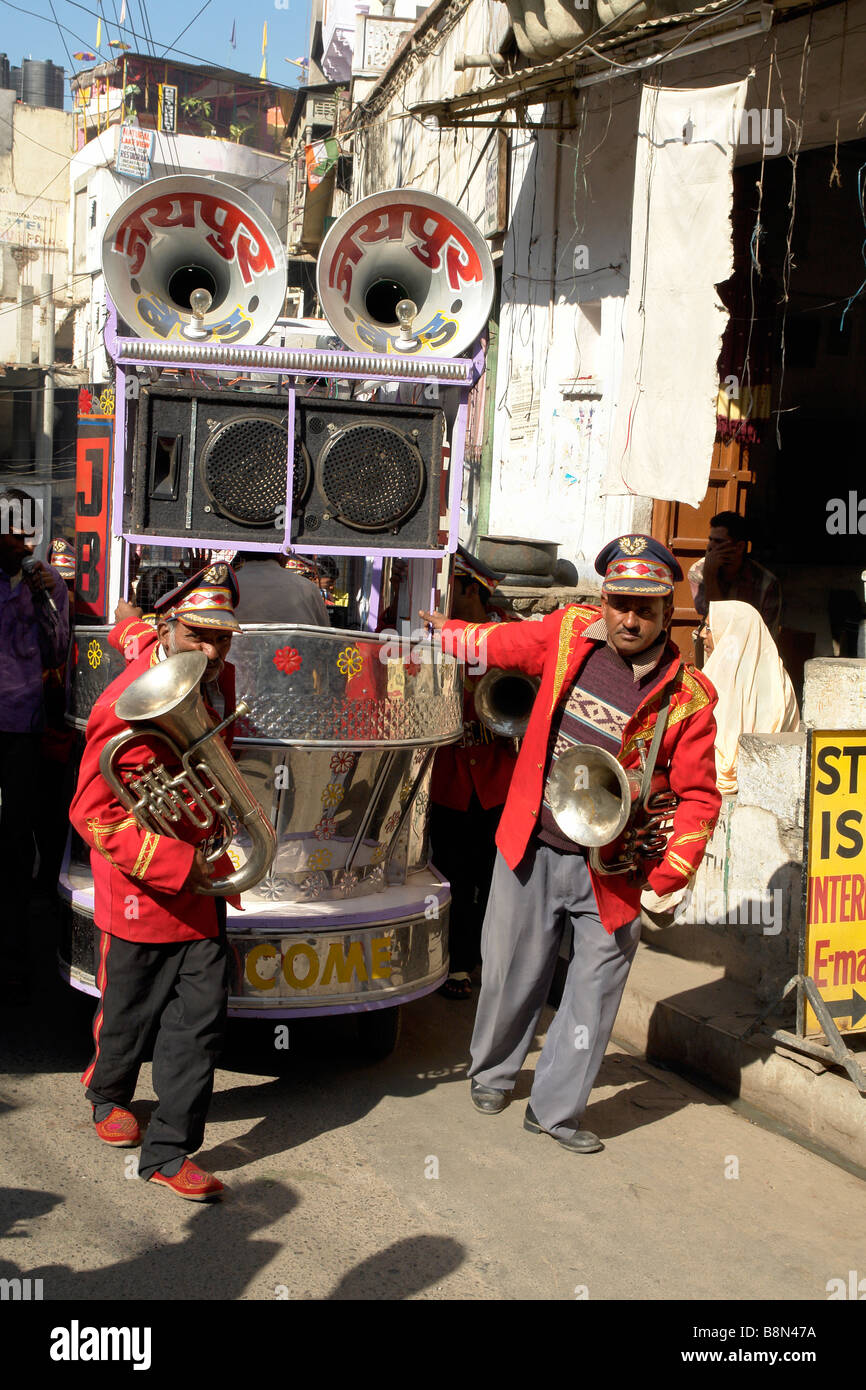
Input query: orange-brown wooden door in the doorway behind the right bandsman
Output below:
<box><xmin>652</xmin><ymin>439</ymin><xmax>755</xmax><ymax>662</ymax></box>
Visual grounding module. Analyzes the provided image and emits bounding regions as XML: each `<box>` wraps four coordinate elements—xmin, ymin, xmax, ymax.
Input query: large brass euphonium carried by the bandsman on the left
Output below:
<box><xmin>99</xmin><ymin>652</ymin><xmax>277</xmax><ymax>897</ymax></box>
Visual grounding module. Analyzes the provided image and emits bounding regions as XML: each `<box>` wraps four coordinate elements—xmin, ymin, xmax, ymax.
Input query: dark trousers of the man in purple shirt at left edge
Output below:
<box><xmin>0</xmin><ymin>731</ymin><xmax>42</xmax><ymax>970</ymax></box>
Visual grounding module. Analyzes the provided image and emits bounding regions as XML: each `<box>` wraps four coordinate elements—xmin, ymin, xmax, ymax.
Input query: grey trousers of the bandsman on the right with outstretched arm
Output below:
<box><xmin>468</xmin><ymin>842</ymin><xmax>641</xmax><ymax>1138</ymax></box>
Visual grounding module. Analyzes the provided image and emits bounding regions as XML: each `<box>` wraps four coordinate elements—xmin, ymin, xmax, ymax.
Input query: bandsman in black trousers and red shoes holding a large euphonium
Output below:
<box><xmin>70</xmin><ymin>564</ymin><xmax>240</xmax><ymax>1201</ymax></box>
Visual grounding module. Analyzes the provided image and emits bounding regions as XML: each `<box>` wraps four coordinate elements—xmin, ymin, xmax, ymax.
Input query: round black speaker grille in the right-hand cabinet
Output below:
<box><xmin>318</xmin><ymin>424</ymin><xmax>424</xmax><ymax>531</ymax></box>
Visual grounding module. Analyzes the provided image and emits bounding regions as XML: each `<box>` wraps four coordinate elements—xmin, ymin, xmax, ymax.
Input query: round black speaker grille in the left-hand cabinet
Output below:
<box><xmin>200</xmin><ymin>413</ymin><xmax>310</xmax><ymax>527</ymax></box>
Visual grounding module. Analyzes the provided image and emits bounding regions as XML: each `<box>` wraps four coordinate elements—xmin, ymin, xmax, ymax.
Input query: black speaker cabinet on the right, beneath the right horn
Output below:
<box><xmin>292</xmin><ymin>396</ymin><xmax>445</xmax><ymax>552</ymax></box>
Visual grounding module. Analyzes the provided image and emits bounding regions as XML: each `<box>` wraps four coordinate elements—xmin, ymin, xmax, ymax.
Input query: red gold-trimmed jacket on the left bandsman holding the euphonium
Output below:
<box><xmin>70</xmin><ymin>619</ymin><xmax>238</xmax><ymax>942</ymax></box>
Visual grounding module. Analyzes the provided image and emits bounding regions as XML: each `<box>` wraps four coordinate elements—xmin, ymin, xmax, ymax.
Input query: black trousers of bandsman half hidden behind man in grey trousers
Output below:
<box><xmin>430</xmin><ymin>792</ymin><xmax>502</xmax><ymax>974</ymax></box>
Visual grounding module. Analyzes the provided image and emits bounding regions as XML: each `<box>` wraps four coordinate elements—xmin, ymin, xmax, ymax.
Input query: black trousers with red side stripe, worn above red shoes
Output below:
<box><xmin>82</xmin><ymin>898</ymin><xmax>228</xmax><ymax>1177</ymax></box>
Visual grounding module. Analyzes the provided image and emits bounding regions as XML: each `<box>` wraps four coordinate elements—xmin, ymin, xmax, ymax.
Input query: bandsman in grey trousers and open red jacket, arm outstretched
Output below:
<box><xmin>421</xmin><ymin>535</ymin><xmax>721</xmax><ymax>1154</ymax></box>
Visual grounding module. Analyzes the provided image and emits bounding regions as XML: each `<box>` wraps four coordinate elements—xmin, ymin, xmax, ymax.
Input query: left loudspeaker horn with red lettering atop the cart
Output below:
<box><xmin>101</xmin><ymin>174</ymin><xmax>288</xmax><ymax>343</ymax></box>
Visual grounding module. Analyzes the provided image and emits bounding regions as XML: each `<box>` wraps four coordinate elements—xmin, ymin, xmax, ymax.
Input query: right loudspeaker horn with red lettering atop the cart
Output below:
<box><xmin>316</xmin><ymin>188</ymin><xmax>493</xmax><ymax>357</ymax></box>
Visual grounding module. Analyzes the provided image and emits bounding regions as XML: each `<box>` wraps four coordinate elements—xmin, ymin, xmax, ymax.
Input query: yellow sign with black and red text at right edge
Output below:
<box><xmin>803</xmin><ymin>730</ymin><xmax>866</xmax><ymax>1036</ymax></box>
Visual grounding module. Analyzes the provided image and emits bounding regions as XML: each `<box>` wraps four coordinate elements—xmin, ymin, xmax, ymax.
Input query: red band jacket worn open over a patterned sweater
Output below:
<box><xmin>442</xmin><ymin>605</ymin><xmax>721</xmax><ymax>931</ymax></box>
